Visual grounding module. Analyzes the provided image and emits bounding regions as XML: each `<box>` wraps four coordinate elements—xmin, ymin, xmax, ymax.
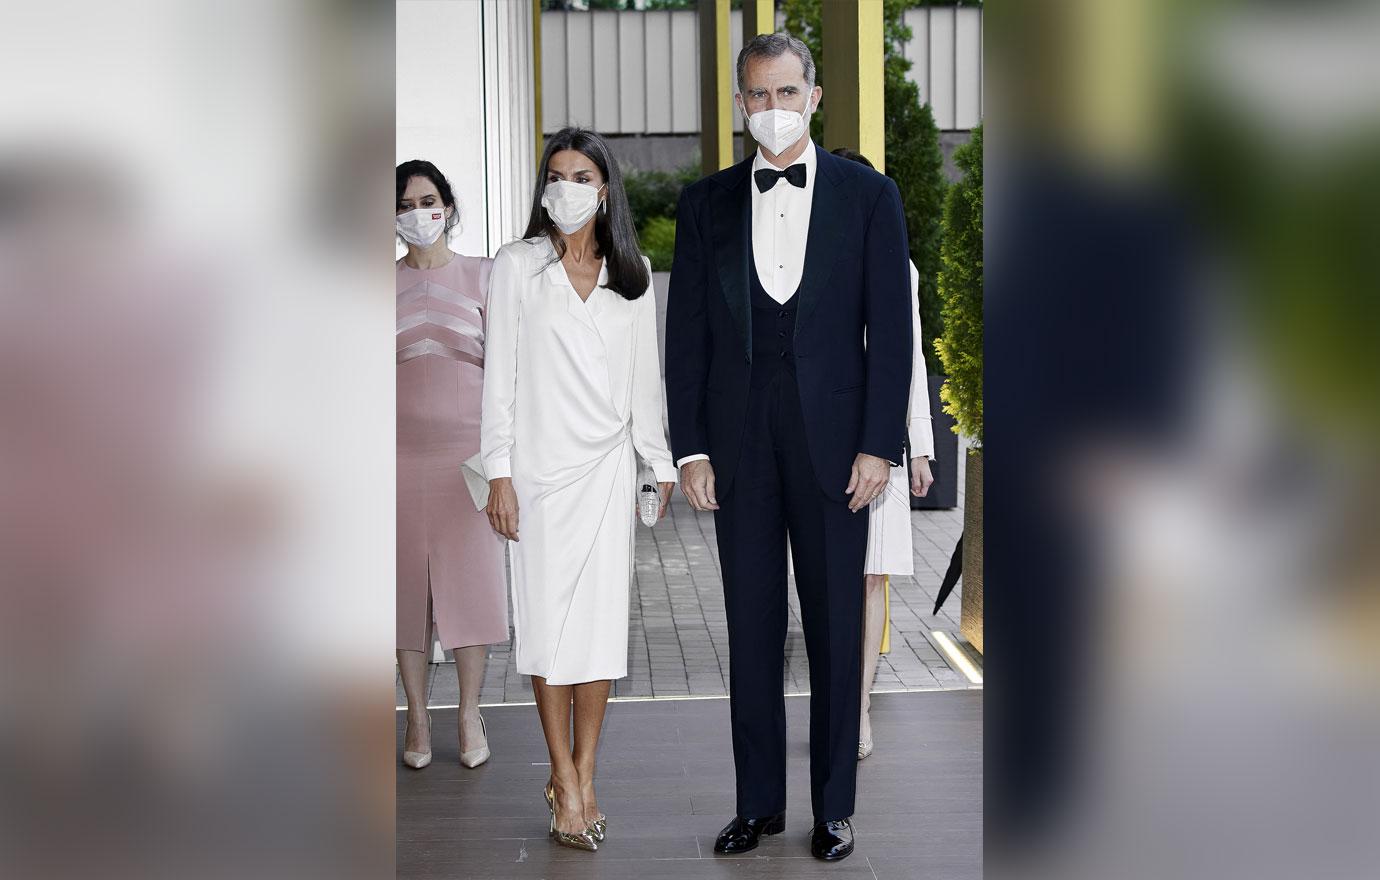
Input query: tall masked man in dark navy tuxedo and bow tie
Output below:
<box><xmin>667</xmin><ymin>33</ymin><xmax>912</xmax><ymax>859</ymax></box>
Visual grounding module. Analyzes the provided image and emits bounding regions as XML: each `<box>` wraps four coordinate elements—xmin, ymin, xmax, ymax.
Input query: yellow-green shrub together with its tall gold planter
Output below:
<box><xmin>936</xmin><ymin>126</ymin><xmax>983</xmax><ymax>651</ymax></box>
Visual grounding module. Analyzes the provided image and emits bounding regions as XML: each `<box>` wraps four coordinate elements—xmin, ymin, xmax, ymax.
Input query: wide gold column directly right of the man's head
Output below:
<box><xmin>820</xmin><ymin>0</ymin><xmax>886</xmax><ymax>171</ymax></box>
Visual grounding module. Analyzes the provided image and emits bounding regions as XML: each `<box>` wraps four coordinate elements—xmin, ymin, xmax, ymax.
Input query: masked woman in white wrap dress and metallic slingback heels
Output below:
<box><xmin>480</xmin><ymin>128</ymin><xmax>676</xmax><ymax>850</ymax></box>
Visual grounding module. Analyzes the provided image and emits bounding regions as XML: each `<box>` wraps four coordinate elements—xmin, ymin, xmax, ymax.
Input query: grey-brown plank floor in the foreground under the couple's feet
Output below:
<box><xmin>397</xmin><ymin>691</ymin><xmax>983</xmax><ymax>880</ymax></box>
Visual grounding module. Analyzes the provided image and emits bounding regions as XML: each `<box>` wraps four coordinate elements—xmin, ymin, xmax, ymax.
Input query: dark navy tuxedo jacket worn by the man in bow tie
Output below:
<box><xmin>667</xmin><ymin>143</ymin><xmax>912</xmax><ymax>499</ymax></box>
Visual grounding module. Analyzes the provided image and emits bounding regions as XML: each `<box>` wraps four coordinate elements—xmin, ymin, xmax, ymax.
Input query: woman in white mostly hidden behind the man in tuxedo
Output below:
<box><xmin>834</xmin><ymin>149</ymin><xmax>934</xmax><ymax>761</ymax></box>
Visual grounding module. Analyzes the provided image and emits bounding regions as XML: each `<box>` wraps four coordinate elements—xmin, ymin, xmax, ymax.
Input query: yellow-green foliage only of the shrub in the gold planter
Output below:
<box><xmin>936</xmin><ymin>126</ymin><xmax>983</xmax><ymax>446</ymax></box>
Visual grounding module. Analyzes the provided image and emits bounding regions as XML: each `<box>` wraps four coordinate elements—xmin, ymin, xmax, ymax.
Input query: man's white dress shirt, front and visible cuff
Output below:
<box><xmin>676</xmin><ymin>142</ymin><xmax>817</xmax><ymax>468</ymax></box>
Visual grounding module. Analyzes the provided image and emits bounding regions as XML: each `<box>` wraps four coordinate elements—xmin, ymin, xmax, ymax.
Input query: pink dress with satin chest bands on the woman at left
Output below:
<box><xmin>397</xmin><ymin>254</ymin><xmax>508</xmax><ymax>651</ymax></box>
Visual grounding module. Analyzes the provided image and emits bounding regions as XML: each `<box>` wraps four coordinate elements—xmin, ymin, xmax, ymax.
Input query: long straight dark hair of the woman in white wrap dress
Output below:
<box><xmin>522</xmin><ymin>127</ymin><xmax>651</xmax><ymax>299</ymax></box>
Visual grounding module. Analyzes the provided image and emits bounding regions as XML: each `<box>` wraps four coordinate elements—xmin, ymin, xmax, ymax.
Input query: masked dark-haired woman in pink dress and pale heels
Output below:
<box><xmin>396</xmin><ymin>160</ymin><xmax>508</xmax><ymax>770</ymax></box>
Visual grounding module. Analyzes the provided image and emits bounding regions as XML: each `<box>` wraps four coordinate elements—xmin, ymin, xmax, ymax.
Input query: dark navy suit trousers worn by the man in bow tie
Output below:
<box><xmin>715</xmin><ymin>370</ymin><xmax>868</xmax><ymax>821</ymax></box>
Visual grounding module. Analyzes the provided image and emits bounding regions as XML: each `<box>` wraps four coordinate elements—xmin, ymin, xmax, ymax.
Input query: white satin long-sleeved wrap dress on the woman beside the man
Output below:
<box><xmin>480</xmin><ymin>239</ymin><xmax>676</xmax><ymax>684</ymax></box>
